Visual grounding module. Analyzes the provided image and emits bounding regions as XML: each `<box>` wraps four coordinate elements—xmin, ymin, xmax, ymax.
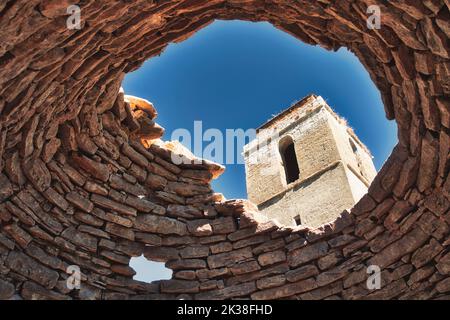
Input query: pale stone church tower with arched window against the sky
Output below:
<box><xmin>244</xmin><ymin>95</ymin><xmax>376</xmax><ymax>227</ymax></box>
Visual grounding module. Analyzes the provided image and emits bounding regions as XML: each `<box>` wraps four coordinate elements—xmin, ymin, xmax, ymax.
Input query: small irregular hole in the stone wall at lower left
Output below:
<box><xmin>130</xmin><ymin>255</ymin><xmax>172</xmax><ymax>283</ymax></box>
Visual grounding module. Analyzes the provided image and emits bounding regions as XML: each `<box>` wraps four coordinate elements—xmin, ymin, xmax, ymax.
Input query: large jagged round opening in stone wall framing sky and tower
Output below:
<box><xmin>123</xmin><ymin>20</ymin><xmax>397</xmax><ymax>226</ymax></box>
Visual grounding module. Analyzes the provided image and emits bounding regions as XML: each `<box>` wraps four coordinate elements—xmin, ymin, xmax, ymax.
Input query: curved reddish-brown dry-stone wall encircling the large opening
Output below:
<box><xmin>0</xmin><ymin>0</ymin><xmax>450</xmax><ymax>299</ymax></box>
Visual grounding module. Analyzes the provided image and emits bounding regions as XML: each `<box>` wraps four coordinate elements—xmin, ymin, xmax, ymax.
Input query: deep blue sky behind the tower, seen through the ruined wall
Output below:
<box><xmin>123</xmin><ymin>21</ymin><xmax>397</xmax><ymax>279</ymax></box>
